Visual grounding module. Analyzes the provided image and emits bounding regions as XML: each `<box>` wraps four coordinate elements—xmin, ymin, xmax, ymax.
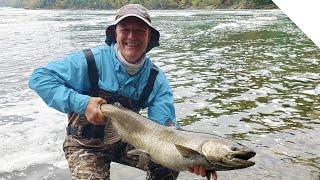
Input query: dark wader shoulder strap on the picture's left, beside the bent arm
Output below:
<box><xmin>83</xmin><ymin>49</ymin><xmax>99</xmax><ymax>97</ymax></box>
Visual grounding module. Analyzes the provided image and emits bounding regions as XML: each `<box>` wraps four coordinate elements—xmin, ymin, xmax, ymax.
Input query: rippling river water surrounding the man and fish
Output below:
<box><xmin>0</xmin><ymin>8</ymin><xmax>320</xmax><ymax>180</ymax></box>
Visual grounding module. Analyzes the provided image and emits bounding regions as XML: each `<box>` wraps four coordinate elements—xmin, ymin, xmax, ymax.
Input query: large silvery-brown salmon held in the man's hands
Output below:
<box><xmin>100</xmin><ymin>104</ymin><xmax>256</xmax><ymax>178</ymax></box>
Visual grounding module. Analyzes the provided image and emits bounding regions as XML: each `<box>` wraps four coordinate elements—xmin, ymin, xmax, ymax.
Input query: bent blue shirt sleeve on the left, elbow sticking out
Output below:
<box><xmin>29</xmin><ymin>52</ymin><xmax>89</xmax><ymax>114</ymax></box>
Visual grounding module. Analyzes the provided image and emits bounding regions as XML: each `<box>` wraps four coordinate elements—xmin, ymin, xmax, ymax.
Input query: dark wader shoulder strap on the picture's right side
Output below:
<box><xmin>138</xmin><ymin>64</ymin><xmax>159</xmax><ymax>108</ymax></box>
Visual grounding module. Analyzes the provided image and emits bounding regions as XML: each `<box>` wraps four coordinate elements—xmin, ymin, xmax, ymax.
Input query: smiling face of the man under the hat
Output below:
<box><xmin>116</xmin><ymin>17</ymin><xmax>150</xmax><ymax>64</ymax></box>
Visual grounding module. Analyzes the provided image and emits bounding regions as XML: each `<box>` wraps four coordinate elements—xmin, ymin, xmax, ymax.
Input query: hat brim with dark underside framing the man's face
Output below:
<box><xmin>105</xmin><ymin>14</ymin><xmax>160</xmax><ymax>52</ymax></box>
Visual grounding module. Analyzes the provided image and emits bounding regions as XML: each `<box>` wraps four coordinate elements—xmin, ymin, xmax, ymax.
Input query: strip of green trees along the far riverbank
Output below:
<box><xmin>0</xmin><ymin>0</ymin><xmax>276</xmax><ymax>9</ymax></box>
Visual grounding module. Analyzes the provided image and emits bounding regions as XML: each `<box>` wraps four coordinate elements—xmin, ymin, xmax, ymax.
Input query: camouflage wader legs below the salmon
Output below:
<box><xmin>63</xmin><ymin>135</ymin><xmax>179</xmax><ymax>180</ymax></box>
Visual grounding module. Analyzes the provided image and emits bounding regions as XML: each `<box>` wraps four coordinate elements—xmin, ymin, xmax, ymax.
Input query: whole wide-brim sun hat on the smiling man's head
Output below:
<box><xmin>106</xmin><ymin>4</ymin><xmax>160</xmax><ymax>52</ymax></box>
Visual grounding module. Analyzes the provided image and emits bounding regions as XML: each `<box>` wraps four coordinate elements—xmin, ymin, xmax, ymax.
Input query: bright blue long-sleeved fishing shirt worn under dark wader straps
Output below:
<box><xmin>29</xmin><ymin>45</ymin><xmax>176</xmax><ymax>125</ymax></box>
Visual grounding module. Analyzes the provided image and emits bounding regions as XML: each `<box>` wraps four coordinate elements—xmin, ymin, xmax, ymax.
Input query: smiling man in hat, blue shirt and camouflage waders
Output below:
<box><xmin>29</xmin><ymin>4</ymin><xmax>215</xmax><ymax>179</ymax></box>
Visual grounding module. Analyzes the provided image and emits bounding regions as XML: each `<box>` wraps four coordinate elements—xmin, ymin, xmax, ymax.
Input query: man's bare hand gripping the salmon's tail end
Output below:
<box><xmin>85</xmin><ymin>97</ymin><xmax>107</xmax><ymax>125</ymax></box>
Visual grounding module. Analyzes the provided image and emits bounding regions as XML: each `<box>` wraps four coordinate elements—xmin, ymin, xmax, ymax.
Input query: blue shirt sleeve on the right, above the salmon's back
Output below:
<box><xmin>148</xmin><ymin>70</ymin><xmax>180</xmax><ymax>127</ymax></box>
